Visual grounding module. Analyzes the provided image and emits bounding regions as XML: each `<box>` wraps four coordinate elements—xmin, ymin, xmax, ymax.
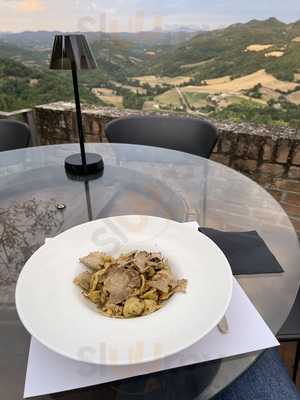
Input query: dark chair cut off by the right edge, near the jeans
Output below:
<box><xmin>278</xmin><ymin>290</ymin><xmax>300</xmax><ymax>382</ymax></box>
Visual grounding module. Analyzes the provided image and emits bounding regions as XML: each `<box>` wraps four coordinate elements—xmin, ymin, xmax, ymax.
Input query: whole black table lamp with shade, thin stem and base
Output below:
<box><xmin>50</xmin><ymin>35</ymin><xmax>104</xmax><ymax>175</ymax></box>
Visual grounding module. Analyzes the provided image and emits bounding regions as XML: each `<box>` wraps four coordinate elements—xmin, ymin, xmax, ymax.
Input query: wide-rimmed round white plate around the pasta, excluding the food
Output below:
<box><xmin>16</xmin><ymin>216</ymin><xmax>232</xmax><ymax>365</ymax></box>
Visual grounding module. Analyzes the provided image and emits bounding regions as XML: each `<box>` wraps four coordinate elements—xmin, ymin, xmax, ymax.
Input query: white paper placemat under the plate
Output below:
<box><xmin>24</xmin><ymin>223</ymin><xmax>279</xmax><ymax>398</ymax></box>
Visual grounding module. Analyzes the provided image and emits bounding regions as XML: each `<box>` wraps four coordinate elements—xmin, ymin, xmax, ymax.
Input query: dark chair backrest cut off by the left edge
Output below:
<box><xmin>0</xmin><ymin>119</ymin><xmax>31</xmax><ymax>151</ymax></box>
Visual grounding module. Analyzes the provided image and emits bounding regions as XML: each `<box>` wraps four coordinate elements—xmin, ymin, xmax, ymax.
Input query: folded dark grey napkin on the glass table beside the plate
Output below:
<box><xmin>199</xmin><ymin>228</ymin><xmax>284</xmax><ymax>275</ymax></box>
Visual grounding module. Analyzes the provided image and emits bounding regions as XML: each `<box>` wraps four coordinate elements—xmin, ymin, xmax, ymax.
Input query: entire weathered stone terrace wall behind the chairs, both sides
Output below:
<box><xmin>35</xmin><ymin>103</ymin><xmax>300</xmax><ymax>234</ymax></box>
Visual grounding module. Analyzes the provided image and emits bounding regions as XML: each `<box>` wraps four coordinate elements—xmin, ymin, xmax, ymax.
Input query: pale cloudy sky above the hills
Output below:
<box><xmin>0</xmin><ymin>0</ymin><xmax>300</xmax><ymax>32</ymax></box>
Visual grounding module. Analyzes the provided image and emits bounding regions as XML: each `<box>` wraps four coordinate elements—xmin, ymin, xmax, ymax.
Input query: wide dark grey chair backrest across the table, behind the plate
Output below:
<box><xmin>105</xmin><ymin>116</ymin><xmax>218</xmax><ymax>158</ymax></box>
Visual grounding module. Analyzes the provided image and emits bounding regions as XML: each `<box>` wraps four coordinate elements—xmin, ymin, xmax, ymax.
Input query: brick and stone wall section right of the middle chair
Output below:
<box><xmin>211</xmin><ymin>123</ymin><xmax>300</xmax><ymax>234</ymax></box>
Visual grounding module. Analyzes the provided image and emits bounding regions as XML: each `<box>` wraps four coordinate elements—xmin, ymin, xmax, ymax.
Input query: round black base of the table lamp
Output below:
<box><xmin>65</xmin><ymin>153</ymin><xmax>104</xmax><ymax>175</ymax></box>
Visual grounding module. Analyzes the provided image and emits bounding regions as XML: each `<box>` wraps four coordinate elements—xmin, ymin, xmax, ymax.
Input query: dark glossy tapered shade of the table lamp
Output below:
<box><xmin>50</xmin><ymin>34</ymin><xmax>97</xmax><ymax>70</ymax></box>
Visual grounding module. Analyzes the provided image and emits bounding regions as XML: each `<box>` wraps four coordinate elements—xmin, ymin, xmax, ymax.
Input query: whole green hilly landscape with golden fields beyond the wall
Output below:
<box><xmin>0</xmin><ymin>18</ymin><xmax>300</xmax><ymax>127</ymax></box>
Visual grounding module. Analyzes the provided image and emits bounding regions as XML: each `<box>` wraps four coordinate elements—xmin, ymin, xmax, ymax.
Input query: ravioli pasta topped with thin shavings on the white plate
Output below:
<box><xmin>74</xmin><ymin>251</ymin><xmax>187</xmax><ymax>318</ymax></box>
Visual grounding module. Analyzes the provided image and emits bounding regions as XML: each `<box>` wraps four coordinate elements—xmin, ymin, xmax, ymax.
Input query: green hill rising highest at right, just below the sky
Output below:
<box><xmin>148</xmin><ymin>18</ymin><xmax>300</xmax><ymax>80</ymax></box>
